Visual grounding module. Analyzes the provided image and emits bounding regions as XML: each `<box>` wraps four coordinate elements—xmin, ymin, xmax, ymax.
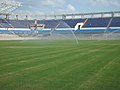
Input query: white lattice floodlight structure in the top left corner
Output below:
<box><xmin>0</xmin><ymin>0</ymin><xmax>22</xmax><ymax>14</ymax></box>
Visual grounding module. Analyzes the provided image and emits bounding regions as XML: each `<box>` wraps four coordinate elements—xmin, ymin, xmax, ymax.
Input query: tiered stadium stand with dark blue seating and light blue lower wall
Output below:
<box><xmin>0</xmin><ymin>13</ymin><xmax>120</xmax><ymax>34</ymax></box>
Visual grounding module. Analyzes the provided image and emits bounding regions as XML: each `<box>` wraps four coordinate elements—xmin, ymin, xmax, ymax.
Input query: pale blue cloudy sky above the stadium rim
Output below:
<box><xmin>14</xmin><ymin>0</ymin><xmax>120</xmax><ymax>15</ymax></box>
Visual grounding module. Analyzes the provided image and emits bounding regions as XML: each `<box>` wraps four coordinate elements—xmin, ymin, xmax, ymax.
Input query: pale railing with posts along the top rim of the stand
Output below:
<box><xmin>0</xmin><ymin>11</ymin><xmax>120</xmax><ymax>20</ymax></box>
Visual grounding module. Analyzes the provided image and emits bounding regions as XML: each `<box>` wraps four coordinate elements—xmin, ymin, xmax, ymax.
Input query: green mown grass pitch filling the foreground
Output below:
<box><xmin>0</xmin><ymin>41</ymin><xmax>120</xmax><ymax>90</ymax></box>
